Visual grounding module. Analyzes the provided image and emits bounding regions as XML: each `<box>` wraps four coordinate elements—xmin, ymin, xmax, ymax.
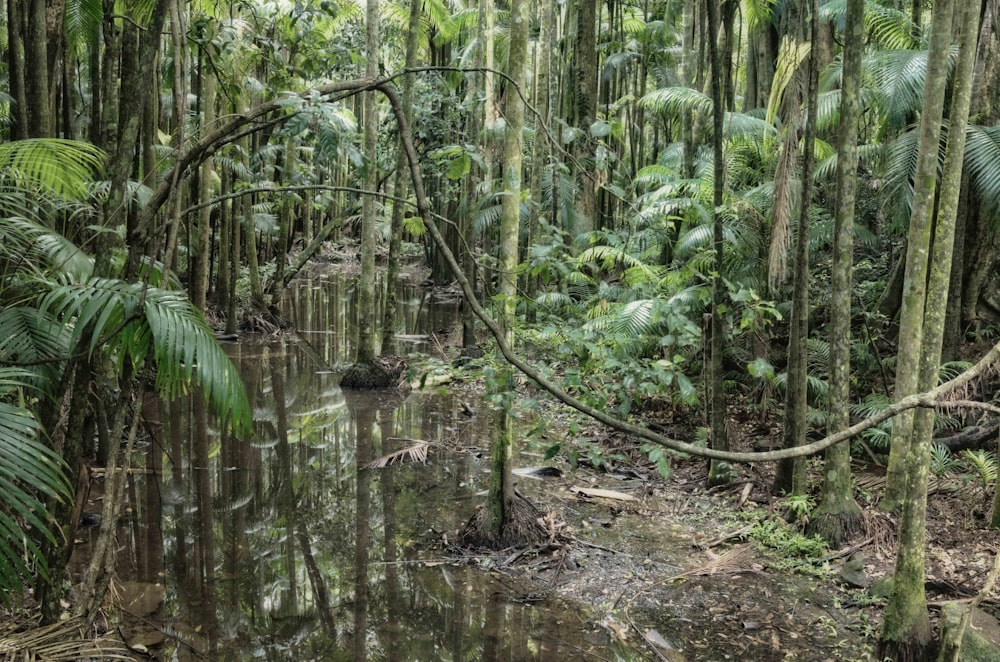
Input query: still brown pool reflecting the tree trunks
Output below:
<box><xmin>95</xmin><ymin>278</ymin><xmax>641</xmax><ymax>660</ymax></box>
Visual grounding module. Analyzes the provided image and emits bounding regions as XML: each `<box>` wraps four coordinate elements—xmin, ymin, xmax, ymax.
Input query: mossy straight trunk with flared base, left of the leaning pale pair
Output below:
<box><xmin>810</xmin><ymin>0</ymin><xmax>864</xmax><ymax>547</ymax></box>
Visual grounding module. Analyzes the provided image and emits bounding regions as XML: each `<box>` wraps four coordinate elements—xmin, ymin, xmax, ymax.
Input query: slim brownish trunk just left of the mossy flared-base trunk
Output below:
<box><xmin>775</xmin><ymin>0</ymin><xmax>820</xmax><ymax>494</ymax></box>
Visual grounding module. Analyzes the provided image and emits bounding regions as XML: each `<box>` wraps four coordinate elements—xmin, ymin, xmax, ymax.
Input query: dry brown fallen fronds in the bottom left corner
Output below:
<box><xmin>0</xmin><ymin>618</ymin><xmax>134</xmax><ymax>660</ymax></box>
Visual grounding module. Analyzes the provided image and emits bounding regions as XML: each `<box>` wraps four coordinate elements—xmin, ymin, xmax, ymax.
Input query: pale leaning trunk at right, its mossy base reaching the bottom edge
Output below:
<box><xmin>879</xmin><ymin>2</ymin><xmax>979</xmax><ymax>660</ymax></box>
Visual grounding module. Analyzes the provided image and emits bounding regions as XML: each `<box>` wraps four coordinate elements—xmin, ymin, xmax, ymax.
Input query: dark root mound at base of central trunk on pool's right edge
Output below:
<box><xmin>458</xmin><ymin>496</ymin><xmax>570</xmax><ymax>550</ymax></box>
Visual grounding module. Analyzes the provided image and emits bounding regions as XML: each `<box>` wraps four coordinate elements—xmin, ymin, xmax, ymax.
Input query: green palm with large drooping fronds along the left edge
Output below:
<box><xmin>0</xmin><ymin>139</ymin><xmax>250</xmax><ymax>612</ymax></box>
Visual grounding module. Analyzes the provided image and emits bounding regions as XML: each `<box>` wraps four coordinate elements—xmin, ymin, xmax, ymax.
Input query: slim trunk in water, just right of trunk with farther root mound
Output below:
<box><xmin>382</xmin><ymin>0</ymin><xmax>423</xmax><ymax>354</ymax></box>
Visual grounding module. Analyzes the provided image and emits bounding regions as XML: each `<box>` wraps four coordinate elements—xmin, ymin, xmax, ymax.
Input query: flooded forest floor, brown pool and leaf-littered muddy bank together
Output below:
<box><xmin>13</xmin><ymin>256</ymin><xmax>1000</xmax><ymax>662</ymax></box>
